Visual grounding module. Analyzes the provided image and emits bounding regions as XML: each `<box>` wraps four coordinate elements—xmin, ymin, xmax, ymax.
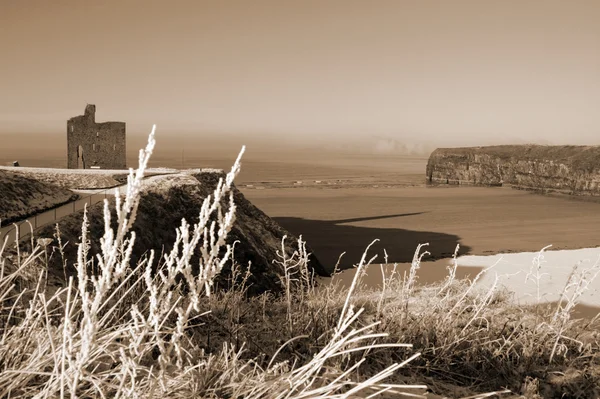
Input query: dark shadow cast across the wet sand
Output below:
<box><xmin>273</xmin><ymin>212</ymin><xmax>470</xmax><ymax>271</ymax></box>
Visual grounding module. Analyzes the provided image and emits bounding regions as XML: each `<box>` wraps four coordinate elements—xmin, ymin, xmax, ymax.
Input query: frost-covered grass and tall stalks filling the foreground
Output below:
<box><xmin>0</xmin><ymin>129</ymin><xmax>600</xmax><ymax>398</ymax></box>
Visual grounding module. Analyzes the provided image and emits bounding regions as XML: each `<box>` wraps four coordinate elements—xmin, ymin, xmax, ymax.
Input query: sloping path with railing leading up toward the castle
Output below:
<box><xmin>0</xmin><ymin>187</ymin><xmax>119</xmax><ymax>247</ymax></box>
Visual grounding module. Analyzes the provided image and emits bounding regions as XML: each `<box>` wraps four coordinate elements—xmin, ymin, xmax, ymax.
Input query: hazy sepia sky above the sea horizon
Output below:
<box><xmin>0</xmin><ymin>0</ymin><xmax>600</xmax><ymax>145</ymax></box>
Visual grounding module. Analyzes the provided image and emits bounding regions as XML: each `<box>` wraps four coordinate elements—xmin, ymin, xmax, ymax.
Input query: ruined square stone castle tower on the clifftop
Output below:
<box><xmin>67</xmin><ymin>104</ymin><xmax>127</xmax><ymax>169</ymax></box>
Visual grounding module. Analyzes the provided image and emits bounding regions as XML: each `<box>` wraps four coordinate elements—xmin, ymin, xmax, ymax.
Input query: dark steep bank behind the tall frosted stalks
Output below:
<box><xmin>31</xmin><ymin>170</ymin><xmax>328</xmax><ymax>295</ymax></box>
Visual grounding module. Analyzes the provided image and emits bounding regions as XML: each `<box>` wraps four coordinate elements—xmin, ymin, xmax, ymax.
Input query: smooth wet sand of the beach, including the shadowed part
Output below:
<box><xmin>242</xmin><ymin>186</ymin><xmax>600</xmax><ymax>267</ymax></box>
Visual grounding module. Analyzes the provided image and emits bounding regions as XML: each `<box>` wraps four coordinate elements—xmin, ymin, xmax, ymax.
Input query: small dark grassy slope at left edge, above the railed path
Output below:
<box><xmin>0</xmin><ymin>170</ymin><xmax>78</xmax><ymax>226</ymax></box>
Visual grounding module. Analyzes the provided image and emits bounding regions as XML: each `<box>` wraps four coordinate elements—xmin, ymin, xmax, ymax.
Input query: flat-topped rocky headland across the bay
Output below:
<box><xmin>426</xmin><ymin>145</ymin><xmax>600</xmax><ymax>195</ymax></box>
